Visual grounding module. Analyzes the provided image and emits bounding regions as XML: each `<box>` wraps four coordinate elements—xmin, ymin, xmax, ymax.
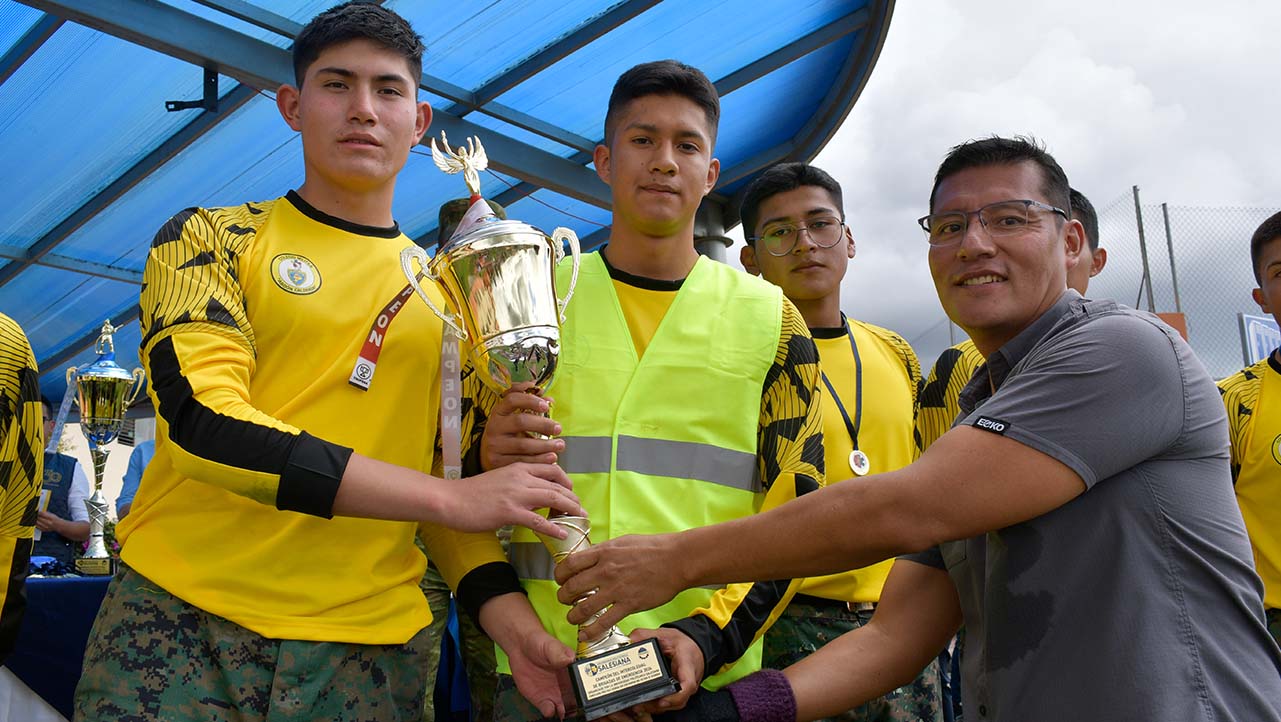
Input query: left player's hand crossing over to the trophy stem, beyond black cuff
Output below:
<box><xmin>453</xmin><ymin>463</ymin><xmax>587</xmax><ymax>539</ymax></box>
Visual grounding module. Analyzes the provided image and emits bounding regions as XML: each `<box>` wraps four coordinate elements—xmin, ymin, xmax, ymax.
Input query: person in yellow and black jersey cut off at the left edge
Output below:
<box><xmin>0</xmin><ymin>314</ymin><xmax>45</xmax><ymax>664</ymax></box>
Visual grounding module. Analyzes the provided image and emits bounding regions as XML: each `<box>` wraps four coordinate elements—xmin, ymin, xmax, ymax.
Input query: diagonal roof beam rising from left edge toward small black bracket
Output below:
<box><xmin>0</xmin><ymin>80</ymin><xmax>255</xmax><ymax>285</ymax></box>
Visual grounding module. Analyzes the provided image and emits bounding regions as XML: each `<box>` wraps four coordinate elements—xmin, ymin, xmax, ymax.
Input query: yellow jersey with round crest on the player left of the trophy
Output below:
<box><xmin>119</xmin><ymin>192</ymin><xmax>502</xmax><ymax>644</ymax></box>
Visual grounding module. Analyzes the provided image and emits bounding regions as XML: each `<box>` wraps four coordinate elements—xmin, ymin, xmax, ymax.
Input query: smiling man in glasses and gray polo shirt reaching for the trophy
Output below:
<box><xmin>557</xmin><ymin>138</ymin><xmax>1281</xmax><ymax>722</ymax></box>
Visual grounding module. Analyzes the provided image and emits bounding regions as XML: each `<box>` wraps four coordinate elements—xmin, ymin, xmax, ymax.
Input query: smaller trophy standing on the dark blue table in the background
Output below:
<box><xmin>67</xmin><ymin>321</ymin><xmax>143</xmax><ymax>575</ymax></box>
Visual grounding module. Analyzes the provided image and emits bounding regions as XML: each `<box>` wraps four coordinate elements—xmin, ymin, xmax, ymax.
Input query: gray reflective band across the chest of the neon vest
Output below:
<box><xmin>559</xmin><ymin>437</ymin><xmax>761</xmax><ymax>493</ymax></box>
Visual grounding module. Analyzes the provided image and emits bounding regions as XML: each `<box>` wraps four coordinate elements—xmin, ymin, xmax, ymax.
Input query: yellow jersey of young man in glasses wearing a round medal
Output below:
<box><xmin>799</xmin><ymin>321</ymin><xmax>921</xmax><ymax>602</ymax></box>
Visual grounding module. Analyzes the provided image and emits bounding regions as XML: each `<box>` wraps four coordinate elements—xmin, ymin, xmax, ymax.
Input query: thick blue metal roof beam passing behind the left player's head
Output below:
<box><xmin>22</xmin><ymin>0</ymin><xmax>608</xmax><ymax>207</ymax></box>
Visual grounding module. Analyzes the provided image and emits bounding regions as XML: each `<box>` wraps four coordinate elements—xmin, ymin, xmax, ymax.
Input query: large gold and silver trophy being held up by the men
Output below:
<box><xmin>401</xmin><ymin>133</ymin><xmax>680</xmax><ymax>719</ymax></box>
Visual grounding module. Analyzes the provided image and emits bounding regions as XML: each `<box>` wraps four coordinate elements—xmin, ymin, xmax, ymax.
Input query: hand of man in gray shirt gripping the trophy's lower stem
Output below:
<box><xmin>556</xmin><ymin>534</ymin><xmax>688</xmax><ymax>639</ymax></box>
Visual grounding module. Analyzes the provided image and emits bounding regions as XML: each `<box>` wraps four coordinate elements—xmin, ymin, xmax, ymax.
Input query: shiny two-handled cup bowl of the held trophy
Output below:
<box><xmin>401</xmin><ymin>220</ymin><xmax>580</xmax><ymax>394</ymax></box>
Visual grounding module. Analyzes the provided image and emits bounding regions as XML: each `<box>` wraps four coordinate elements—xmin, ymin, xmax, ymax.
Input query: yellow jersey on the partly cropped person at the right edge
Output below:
<box><xmin>1218</xmin><ymin>349</ymin><xmax>1281</xmax><ymax>608</ymax></box>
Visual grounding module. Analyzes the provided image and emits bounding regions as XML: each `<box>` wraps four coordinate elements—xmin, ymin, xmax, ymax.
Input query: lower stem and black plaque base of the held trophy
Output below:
<box><xmin>538</xmin><ymin>516</ymin><xmax>680</xmax><ymax>719</ymax></box>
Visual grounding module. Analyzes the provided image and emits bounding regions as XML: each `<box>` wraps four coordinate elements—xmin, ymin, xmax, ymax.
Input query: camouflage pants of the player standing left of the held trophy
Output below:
<box><xmin>76</xmin><ymin>563</ymin><xmax>427</xmax><ymax>722</ymax></box>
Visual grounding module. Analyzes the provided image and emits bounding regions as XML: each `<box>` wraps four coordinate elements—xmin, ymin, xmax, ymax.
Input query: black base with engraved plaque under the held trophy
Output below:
<box><xmin>569</xmin><ymin>638</ymin><xmax>680</xmax><ymax>721</ymax></box>
